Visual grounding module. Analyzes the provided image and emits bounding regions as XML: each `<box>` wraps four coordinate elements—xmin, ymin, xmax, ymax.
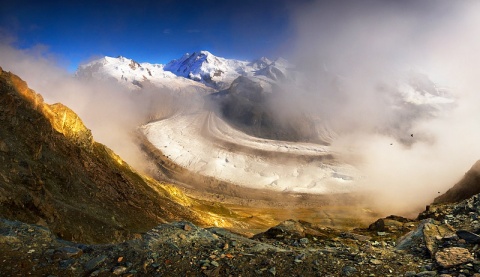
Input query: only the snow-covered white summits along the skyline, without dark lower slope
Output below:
<box><xmin>76</xmin><ymin>51</ymin><xmax>292</xmax><ymax>92</ymax></box>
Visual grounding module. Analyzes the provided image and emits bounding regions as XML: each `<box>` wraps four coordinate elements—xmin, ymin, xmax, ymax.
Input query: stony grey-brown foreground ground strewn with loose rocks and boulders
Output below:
<box><xmin>0</xmin><ymin>191</ymin><xmax>480</xmax><ymax>277</ymax></box>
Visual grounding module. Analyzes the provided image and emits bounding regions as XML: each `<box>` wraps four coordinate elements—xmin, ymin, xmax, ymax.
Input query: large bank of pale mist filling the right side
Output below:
<box><xmin>287</xmin><ymin>1</ymin><xmax>480</xmax><ymax>211</ymax></box>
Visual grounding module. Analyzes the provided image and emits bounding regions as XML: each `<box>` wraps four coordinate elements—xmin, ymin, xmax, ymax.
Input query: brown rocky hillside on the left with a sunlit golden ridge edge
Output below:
<box><xmin>0</xmin><ymin>68</ymin><xmax>234</xmax><ymax>243</ymax></box>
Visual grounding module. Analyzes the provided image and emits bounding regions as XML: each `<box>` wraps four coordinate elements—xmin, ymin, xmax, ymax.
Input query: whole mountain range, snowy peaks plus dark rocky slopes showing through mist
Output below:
<box><xmin>75</xmin><ymin>51</ymin><xmax>455</xmax><ymax>144</ymax></box>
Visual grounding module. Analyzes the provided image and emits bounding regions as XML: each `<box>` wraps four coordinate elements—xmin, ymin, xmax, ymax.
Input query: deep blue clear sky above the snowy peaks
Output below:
<box><xmin>0</xmin><ymin>0</ymin><xmax>305</xmax><ymax>71</ymax></box>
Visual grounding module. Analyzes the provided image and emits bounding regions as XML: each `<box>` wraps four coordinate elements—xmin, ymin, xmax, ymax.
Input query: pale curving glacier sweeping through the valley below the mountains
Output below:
<box><xmin>142</xmin><ymin>111</ymin><xmax>359</xmax><ymax>194</ymax></box>
